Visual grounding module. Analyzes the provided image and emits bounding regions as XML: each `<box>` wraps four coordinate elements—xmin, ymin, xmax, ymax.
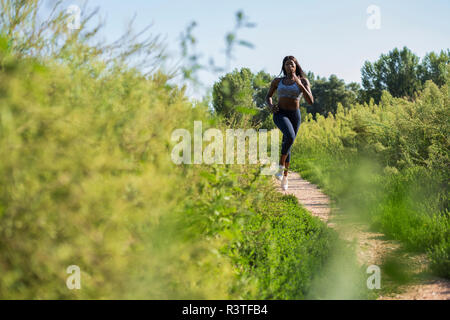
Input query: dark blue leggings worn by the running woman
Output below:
<box><xmin>273</xmin><ymin>108</ymin><xmax>302</xmax><ymax>163</ymax></box>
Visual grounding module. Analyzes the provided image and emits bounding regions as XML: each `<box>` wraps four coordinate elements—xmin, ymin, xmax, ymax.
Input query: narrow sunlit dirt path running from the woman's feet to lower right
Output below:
<box><xmin>273</xmin><ymin>171</ymin><xmax>450</xmax><ymax>300</ymax></box>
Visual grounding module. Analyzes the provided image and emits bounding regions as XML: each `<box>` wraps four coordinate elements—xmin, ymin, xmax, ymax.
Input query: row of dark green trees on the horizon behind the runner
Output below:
<box><xmin>212</xmin><ymin>46</ymin><xmax>450</xmax><ymax>129</ymax></box>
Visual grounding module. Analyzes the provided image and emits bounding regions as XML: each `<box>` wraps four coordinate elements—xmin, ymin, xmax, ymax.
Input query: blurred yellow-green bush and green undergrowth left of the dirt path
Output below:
<box><xmin>0</xmin><ymin>39</ymin><xmax>362</xmax><ymax>299</ymax></box>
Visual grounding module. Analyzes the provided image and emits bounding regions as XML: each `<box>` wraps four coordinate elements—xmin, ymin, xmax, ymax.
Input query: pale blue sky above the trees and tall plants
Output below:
<box><xmin>58</xmin><ymin>0</ymin><xmax>450</xmax><ymax>97</ymax></box>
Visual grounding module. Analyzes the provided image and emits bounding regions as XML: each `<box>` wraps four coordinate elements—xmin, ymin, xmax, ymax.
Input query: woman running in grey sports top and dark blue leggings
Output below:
<box><xmin>266</xmin><ymin>56</ymin><xmax>314</xmax><ymax>190</ymax></box>
